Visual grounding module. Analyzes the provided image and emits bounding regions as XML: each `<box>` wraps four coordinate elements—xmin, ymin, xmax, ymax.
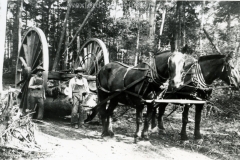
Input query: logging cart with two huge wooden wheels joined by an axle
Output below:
<box><xmin>15</xmin><ymin>27</ymin><xmax>109</xmax><ymax>114</ymax></box>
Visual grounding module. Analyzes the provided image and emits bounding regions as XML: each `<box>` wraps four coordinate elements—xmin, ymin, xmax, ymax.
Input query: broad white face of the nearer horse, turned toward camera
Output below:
<box><xmin>168</xmin><ymin>52</ymin><xmax>185</xmax><ymax>90</ymax></box>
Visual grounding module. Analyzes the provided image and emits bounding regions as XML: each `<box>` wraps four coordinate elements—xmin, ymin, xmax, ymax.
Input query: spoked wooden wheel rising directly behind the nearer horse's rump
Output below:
<box><xmin>73</xmin><ymin>38</ymin><xmax>109</xmax><ymax>75</ymax></box>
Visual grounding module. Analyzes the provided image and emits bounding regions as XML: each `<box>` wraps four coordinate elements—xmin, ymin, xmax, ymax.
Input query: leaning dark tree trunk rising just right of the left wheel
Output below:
<box><xmin>52</xmin><ymin>0</ymin><xmax>72</xmax><ymax>71</ymax></box>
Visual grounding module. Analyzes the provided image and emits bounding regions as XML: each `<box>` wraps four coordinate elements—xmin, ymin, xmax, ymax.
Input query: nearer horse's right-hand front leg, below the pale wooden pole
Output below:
<box><xmin>141</xmin><ymin>104</ymin><xmax>153</xmax><ymax>140</ymax></box>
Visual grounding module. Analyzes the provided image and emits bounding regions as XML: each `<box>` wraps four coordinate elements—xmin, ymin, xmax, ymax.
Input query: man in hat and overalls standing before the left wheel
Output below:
<box><xmin>26</xmin><ymin>66</ymin><xmax>46</xmax><ymax>119</ymax></box>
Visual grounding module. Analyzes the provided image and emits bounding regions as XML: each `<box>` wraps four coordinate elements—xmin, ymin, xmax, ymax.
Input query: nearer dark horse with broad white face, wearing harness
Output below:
<box><xmin>85</xmin><ymin>51</ymin><xmax>185</xmax><ymax>140</ymax></box>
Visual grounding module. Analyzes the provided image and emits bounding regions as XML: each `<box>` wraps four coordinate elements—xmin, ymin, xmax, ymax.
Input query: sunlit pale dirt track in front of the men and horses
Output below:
<box><xmin>33</xmin><ymin>119</ymin><xmax>210</xmax><ymax>160</ymax></box>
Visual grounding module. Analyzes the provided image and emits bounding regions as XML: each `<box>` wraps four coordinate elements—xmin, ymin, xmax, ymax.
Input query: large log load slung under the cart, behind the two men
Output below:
<box><xmin>44</xmin><ymin>74</ymin><xmax>97</xmax><ymax>116</ymax></box>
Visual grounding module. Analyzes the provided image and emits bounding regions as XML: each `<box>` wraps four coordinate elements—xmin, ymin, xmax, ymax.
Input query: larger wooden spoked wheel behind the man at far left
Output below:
<box><xmin>15</xmin><ymin>27</ymin><xmax>49</xmax><ymax>110</ymax></box>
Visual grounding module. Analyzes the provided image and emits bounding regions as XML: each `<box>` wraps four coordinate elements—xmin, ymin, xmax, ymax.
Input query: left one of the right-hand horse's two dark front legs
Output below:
<box><xmin>181</xmin><ymin>104</ymin><xmax>190</xmax><ymax>140</ymax></box>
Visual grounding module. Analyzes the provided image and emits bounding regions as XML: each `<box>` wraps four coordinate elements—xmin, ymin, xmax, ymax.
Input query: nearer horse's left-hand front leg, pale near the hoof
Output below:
<box><xmin>134</xmin><ymin>105</ymin><xmax>144</xmax><ymax>143</ymax></box>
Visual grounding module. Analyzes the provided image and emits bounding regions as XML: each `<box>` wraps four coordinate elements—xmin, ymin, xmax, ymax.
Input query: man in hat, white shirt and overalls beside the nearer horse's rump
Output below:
<box><xmin>68</xmin><ymin>67</ymin><xmax>89</xmax><ymax>129</ymax></box>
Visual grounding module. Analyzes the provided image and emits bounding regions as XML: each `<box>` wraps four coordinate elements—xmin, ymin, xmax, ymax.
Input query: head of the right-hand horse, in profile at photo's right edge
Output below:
<box><xmin>220</xmin><ymin>53</ymin><xmax>240</xmax><ymax>89</ymax></box>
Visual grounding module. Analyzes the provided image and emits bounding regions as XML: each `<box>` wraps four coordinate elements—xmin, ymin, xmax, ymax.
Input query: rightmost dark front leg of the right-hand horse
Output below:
<box><xmin>194</xmin><ymin>104</ymin><xmax>203</xmax><ymax>140</ymax></box>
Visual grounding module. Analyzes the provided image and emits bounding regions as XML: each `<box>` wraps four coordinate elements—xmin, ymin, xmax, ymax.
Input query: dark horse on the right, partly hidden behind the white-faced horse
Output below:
<box><xmin>152</xmin><ymin>54</ymin><xmax>239</xmax><ymax>140</ymax></box>
